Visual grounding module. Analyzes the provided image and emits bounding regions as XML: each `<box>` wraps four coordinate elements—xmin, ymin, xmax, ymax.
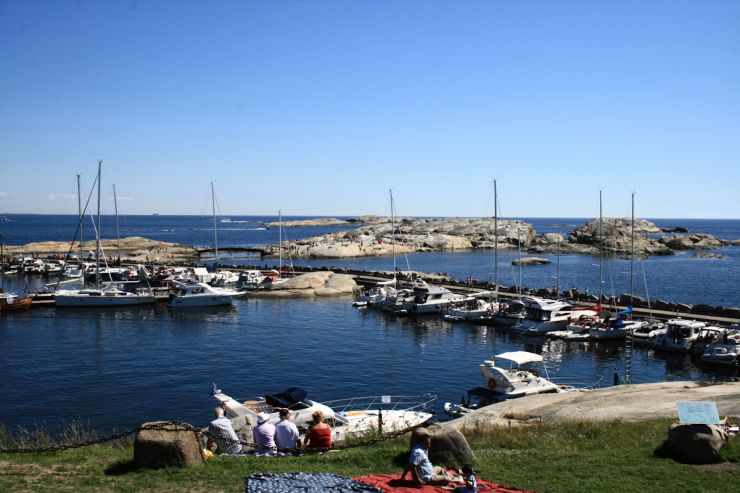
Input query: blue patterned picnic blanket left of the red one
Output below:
<box><xmin>244</xmin><ymin>472</ymin><xmax>382</xmax><ymax>493</ymax></box>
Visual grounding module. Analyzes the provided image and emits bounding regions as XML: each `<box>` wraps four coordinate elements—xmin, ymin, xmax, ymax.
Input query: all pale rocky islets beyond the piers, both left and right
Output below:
<box><xmin>6</xmin><ymin>216</ymin><xmax>740</xmax><ymax>265</ymax></box>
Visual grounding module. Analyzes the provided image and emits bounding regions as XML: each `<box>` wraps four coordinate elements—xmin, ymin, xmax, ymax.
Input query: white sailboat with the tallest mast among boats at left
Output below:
<box><xmin>54</xmin><ymin>161</ymin><xmax>157</xmax><ymax>308</ymax></box>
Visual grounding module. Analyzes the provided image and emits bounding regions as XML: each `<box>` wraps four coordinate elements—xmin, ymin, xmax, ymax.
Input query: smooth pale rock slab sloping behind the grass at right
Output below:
<box><xmin>450</xmin><ymin>382</ymin><xmax>740</xmax><ymax>428</ymax></box>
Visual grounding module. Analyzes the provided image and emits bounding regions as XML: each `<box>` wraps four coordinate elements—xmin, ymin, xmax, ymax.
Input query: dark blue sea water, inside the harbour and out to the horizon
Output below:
<box><xmin>0</xmin><ymin>214</ymin><xmax>740</xmax><ymax>434</ymax></box>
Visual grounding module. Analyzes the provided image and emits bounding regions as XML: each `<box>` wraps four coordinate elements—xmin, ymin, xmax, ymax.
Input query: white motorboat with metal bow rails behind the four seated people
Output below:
<box><xmin>212</xmin><ymin>384</ymin><xmax>437</xmax><ymax>442</ymax></box>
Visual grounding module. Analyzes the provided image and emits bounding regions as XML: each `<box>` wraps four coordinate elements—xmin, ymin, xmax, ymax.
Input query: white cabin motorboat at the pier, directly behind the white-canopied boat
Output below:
<box><xmin>512</xmin><ymin>296</ymin><xmax>598</xmax><ymax>335</ymax></box>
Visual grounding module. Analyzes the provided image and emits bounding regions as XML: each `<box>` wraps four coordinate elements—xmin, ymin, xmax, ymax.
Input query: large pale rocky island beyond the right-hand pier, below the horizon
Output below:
<box><xmin>265</xmin><ymin>216</ymin><xmax>740</xmax><ymax>263</ymax></box>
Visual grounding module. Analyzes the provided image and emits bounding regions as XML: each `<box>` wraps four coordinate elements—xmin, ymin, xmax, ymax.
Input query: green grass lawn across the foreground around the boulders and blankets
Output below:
<box><xmin>0</xmin><ymin>420</ymin><xmax>740</xmax><ymax>493</ymax></box>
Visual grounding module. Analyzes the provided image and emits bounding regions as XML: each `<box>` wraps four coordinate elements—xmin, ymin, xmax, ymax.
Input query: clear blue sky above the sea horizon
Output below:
<box><xmin>0</xmin><ymin>0</ymin><xmax>740</xmax><ymax>218</ymax></box>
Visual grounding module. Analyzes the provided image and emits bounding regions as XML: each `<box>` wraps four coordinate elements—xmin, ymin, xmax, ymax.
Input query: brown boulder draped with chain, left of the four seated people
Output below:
<box><xmin>134</xmin><ymin>421</ymin><xmax>203</xmax><ymax>469</ymax></box>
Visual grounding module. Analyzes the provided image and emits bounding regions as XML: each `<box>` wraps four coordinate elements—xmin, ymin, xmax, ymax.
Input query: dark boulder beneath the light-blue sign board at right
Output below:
<box><xmin>663</xmin><ymin>423</ymin><xmax>728</xmax><ymax>464</ymax></box>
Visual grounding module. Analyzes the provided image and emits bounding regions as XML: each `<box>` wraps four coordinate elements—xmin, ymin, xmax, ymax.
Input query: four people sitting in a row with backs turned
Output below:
<box><xmin>206</xmin><ymin>407</ymin><xmax>333</xmax><ymax>456</ymax></box>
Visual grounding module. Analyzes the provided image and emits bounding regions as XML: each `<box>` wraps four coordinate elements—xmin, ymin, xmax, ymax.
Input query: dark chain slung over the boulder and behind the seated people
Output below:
<box><xmin>0</xmin><ymin>421</ymin><xmax>424</xmax><ymax>454</ymax></box>
